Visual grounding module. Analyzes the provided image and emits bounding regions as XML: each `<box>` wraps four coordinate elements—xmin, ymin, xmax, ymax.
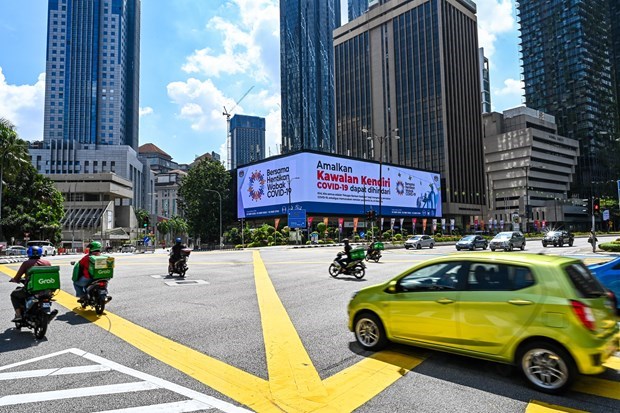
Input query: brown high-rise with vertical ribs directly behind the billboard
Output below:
<box><xmin>334</xmin><ymin>0</ymin><xmax>485</xmax><ymax>228</ymax></box>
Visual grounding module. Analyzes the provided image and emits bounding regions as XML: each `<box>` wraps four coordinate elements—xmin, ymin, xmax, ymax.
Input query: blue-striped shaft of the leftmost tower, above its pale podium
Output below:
<box><xmin>43</xmin><ymin>0</ymin><xmax>140</xmax><ymax>150</ymax></box>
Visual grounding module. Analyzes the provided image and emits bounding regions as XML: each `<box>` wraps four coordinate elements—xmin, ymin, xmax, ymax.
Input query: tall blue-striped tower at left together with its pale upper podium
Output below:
<box><xmin>30</xmin><ymin>0</ymin><xmax>152</xmax><ymax>207</ymax></box>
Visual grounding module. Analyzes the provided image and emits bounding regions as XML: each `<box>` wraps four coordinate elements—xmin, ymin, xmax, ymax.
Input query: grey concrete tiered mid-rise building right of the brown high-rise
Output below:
<box><xmin>483</xmin><ymin>107</ymin><xmax>589</xmax><ymax>232</ymax></box>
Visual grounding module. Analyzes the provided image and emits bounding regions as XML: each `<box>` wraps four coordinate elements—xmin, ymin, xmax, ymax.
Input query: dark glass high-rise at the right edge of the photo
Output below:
<box><xmin>517</xmin><ymin>0</ymin><xmax>620</xmax><ymax>198</ymax></box>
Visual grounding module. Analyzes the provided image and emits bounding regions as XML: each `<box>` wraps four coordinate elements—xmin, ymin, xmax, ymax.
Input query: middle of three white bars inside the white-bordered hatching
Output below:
<box><xmin>0</xmin><ymin>381</ymin><xmax>160</xmax><ymax>406</ymax></box>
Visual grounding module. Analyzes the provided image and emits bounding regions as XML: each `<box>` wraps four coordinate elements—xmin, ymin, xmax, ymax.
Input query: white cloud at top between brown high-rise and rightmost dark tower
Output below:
<box><xmin>476</xmin><ymin>0</ymin><xmax>517</xmax><ymax>57</ymax></box>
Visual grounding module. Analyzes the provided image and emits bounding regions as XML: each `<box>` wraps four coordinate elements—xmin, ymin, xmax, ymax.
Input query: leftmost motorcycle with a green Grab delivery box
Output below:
<box><xmin>15</xmin><ymin>266</ymin><xmax>60</xmax><ymax>340</ymax></box>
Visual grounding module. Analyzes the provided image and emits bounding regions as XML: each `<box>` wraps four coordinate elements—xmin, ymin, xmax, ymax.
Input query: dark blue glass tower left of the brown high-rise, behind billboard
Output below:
<box><xmin>280</xmin><ymin>0</ymin><xmax>340</xmax><ymax>153</ymax></box>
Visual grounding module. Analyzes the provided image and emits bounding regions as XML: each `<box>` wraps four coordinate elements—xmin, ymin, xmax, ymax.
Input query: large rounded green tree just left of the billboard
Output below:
<box><xmin>179</xmin><ymin>158</ymin><xmax>235</xmax><ymax>243</ymax></box>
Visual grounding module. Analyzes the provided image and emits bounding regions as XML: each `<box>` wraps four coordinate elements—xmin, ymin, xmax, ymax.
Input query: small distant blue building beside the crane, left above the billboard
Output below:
<box><xmin>230</xmin><ymin>115</ymin><xmax>265</xmax><ymax>169</ymax></box>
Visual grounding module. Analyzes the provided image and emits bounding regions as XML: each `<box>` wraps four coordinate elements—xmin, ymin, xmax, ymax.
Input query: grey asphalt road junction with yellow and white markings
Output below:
<box><xmin>0</xmin><ymin>237</ymin><xmax>620</xmax><ymax>413</ymax></box>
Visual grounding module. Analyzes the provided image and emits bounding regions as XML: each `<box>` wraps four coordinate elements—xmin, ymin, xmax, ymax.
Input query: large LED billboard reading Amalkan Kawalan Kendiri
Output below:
<box><xmin>237</xmin><ymin>152</ymin><xmax>441</xmax><ymax>218</ymax></box>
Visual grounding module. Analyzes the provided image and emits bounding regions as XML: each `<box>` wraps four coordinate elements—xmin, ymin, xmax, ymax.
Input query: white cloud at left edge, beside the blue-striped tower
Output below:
<box><xmin>0</xmin><ymin>67</ymin><xmax>45</xmax><ymax>141</ymax></box>
